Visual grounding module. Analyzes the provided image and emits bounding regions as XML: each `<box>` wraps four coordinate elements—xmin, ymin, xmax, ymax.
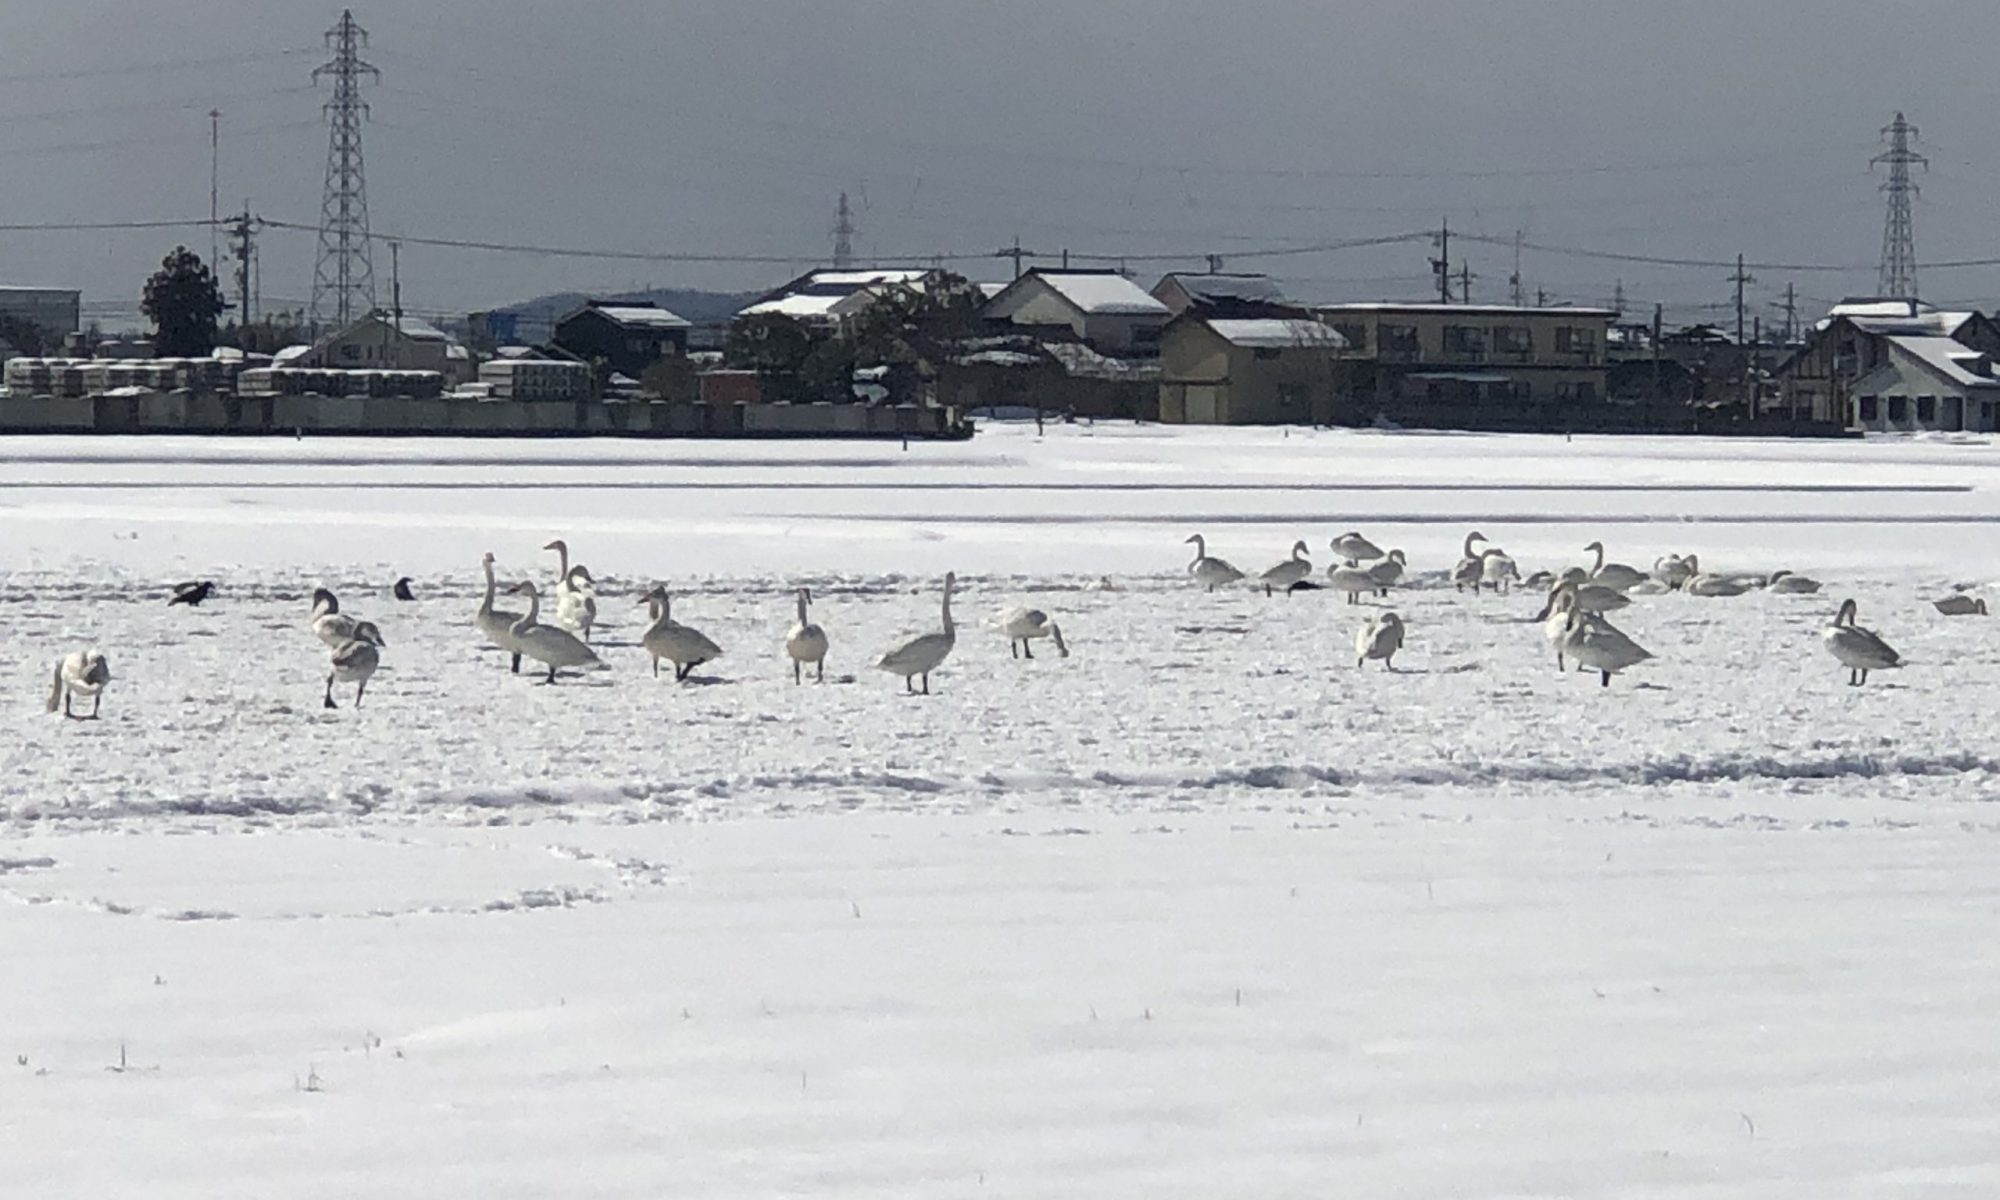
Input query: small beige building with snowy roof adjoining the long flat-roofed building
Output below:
<box><xmin>1160</xmin><ymin>312</ymin><xmax>1346</xmax><ymax>424</ymax></box>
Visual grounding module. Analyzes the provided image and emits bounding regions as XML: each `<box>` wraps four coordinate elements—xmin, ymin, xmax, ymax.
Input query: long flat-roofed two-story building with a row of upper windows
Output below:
<box><xmin>1312</xmin><ymin>302</ymin><xmax>1618</xmax><ymax>420</ymax></box>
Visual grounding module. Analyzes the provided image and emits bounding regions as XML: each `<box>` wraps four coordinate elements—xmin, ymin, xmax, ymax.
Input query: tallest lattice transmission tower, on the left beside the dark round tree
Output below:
<box><xmin>312</xmin><ymin>12</ymin><xmax>382</xmax><ymax>326</ymax></box>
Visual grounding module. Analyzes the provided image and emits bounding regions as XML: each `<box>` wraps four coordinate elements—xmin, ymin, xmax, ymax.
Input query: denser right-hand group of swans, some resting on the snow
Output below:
<box><xmin>1188</xmin><ymin>530</ymin><xmax>1952</xmax><ymax>688</ymax></box>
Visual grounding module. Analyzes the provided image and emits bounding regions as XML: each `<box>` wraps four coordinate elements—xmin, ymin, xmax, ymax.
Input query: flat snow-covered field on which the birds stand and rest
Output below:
<box><xmin>0</xmin><ymin>426</ymin><xmax>2000</xmax><ymax>1200</ymax></box>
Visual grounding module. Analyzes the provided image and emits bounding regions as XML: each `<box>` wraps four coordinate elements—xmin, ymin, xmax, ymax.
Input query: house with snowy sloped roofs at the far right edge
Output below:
<box><xmin>1776</xmin><ymin>298</ymin><xmax>2000</xmax><ymax>432</ymax></box>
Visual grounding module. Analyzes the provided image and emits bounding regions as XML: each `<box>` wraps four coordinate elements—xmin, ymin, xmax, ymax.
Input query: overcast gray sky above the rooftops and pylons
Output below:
<box><xmin>0</xmin><ymin>0</ymin><xmax>2000</xmax><ymax>320</ymax></box>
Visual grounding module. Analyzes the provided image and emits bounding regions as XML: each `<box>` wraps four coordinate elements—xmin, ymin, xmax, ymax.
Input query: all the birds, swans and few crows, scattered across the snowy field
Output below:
<box><xmin>48</xmin><ymin>530</ymin><xmax>1986</xmax><ymax>720</ymax></box>
